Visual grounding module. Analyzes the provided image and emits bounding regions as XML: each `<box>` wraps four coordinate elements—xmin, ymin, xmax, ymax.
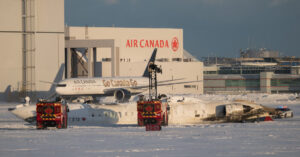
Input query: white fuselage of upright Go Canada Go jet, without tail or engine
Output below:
<box><xmin>55</xmin><ymin>77</ymin><xmax>149</xmax><ymax>96</ymax></box>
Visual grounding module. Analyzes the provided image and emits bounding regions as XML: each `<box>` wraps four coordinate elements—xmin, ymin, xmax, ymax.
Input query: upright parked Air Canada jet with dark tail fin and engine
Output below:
<box><xmin>55</xmin><ymin>48</ymin><xmax>157</xmax><ymax>102</ymax></box>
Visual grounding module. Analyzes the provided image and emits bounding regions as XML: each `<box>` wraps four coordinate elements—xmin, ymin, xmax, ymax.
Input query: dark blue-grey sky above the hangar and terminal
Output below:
<box><xmin>65</xmin><ymin>0</ymin><xmax>300</xmax><ymax>58</ymax></box>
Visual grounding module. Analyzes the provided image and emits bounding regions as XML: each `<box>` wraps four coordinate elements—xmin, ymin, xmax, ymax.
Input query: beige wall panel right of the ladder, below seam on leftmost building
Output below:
<box><xmin>35</xmin><ymin>33</ymin><xmax>65</xmax><ymax>96</ymax></box>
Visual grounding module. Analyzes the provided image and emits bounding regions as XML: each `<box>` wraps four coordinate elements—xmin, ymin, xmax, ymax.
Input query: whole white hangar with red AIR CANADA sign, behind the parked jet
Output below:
<box><xmin>65</xmin><ymin>27</ymin><xmax>203</xmax><ymax>94</ymax></box>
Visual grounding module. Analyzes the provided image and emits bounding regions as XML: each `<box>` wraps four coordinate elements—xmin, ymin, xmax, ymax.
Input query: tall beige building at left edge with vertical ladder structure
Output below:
<box><xmin>0</xmin><ymin>0</ymin><xmax>65</xmax><ymax>101</ymax></box>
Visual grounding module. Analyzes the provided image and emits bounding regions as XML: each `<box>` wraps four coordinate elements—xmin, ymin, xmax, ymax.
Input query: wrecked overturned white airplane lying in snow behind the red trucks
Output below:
<box><xmin>9</xmin><ymin>98</ymin><xmax>275</xmax><ymax>126</ymax></box>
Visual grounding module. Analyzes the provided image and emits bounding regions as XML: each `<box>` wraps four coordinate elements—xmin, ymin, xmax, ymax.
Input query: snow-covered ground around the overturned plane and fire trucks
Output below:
<box><xmin>0</xmin><ymin>94</ymin><xmax>300</xmax><ymax>157</ymax></box>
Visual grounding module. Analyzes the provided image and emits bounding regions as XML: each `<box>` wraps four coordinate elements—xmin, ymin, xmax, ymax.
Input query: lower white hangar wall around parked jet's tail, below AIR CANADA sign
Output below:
<box><xmin>120</xmin><ymin>62</ymin><xmax>203</xmax><ymax>94</ymax></box>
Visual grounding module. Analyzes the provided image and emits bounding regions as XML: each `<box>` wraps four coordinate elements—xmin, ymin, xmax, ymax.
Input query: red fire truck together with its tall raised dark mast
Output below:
<box><xmin>137</xmin><ymin>58</ymin><xmax>169</xmax><ymax>131</ymax></box>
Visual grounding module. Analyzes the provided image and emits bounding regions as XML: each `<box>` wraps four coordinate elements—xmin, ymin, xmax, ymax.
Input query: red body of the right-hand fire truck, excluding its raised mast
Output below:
<box><xmin>137</xmin><ymin>95</ymin><xmax>169</xmax><ymax>131</ymax></box>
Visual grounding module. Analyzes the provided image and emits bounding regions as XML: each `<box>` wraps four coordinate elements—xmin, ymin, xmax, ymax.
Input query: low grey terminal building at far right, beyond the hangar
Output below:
<box><xmin>204</xmin><ymin>48</ymin><xmax>300</xmax><ymax>94</ymax></box>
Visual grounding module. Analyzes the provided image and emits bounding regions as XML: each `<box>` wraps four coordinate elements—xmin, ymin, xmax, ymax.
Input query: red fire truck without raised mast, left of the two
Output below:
<box><xmin>36</xmin><ymin>100</ymin><xmax>69</xmax><ymax>129</ymax></box>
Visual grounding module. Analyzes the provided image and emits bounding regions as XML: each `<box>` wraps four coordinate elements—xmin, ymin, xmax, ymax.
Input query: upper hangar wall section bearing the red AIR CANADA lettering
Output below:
<box><xmin>66</xmin><ymin>27</ymin><xmax>183</xmax><ymax>62</ymax></box>
